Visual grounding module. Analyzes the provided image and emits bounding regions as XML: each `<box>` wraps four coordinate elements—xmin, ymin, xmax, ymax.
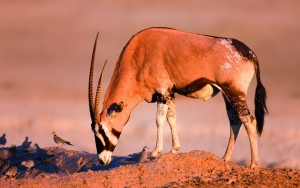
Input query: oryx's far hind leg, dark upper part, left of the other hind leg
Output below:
<box><xmin>223</xmin><ymin>94</ymin><xmax>242</xmax><ymax>162</ymax></box>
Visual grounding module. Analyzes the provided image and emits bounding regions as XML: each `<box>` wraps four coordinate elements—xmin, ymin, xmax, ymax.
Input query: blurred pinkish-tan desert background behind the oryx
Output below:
<box><xmin>0</xmin><ymin>0</ymin><xmax>300</xmax><ymax>169</ymax></box>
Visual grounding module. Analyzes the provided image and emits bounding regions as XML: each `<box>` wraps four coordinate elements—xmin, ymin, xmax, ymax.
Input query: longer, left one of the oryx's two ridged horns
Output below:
<box><xmin>88</xmin><ymin>32</ymin><xmax>99</xmax><ymax>122</ymax></box>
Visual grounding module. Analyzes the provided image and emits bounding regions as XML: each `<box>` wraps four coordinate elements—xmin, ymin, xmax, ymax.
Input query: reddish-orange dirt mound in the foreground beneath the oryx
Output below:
<box><xmin>0</xmin><ymin>148</ymin><xmax>300</xmax><ymax>187</ymax></box>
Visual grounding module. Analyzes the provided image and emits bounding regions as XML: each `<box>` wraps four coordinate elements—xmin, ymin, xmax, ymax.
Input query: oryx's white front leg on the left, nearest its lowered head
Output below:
<box><xmin>151</xmin><ymin>102</ymin><xmax>168</xmax><ymax>157</ymax></box>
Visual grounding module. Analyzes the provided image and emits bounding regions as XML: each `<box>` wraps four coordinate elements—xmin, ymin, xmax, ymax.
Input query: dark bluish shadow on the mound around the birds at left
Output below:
<box><xmin>0</xmin><ymin>144</ymin><xmax>151</xmax><ymax>179</ymax></box>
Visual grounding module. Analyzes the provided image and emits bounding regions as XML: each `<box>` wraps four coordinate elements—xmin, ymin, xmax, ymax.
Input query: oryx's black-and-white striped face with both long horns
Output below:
<box><xmin>88</xmin><ymin>33</ymin><xmax>120</xmax><ymax>165</ymax></box>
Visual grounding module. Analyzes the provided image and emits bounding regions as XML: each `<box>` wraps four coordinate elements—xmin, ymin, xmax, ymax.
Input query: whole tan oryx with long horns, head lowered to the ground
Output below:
<box><xmin>88</xmin><ymin>28</ymin><xmax>268</xmax><ymax>168</ymax></box>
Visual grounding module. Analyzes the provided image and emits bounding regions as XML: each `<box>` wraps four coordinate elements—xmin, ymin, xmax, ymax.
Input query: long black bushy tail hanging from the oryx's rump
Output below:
<box><xmin>254</xmin><ymin>65</ymin><xmax>268</xmax><ymax>136</ymax></box>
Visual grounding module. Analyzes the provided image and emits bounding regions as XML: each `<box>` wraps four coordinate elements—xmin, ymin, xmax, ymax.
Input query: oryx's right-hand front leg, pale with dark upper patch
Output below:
<box><xmin>167</xmin><ymin>94</ymin><xmax>180</xmax><ymax>153</ymax></box>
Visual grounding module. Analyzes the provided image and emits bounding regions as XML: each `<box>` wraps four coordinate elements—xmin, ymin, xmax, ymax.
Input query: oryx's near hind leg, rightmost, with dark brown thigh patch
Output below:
<box><xmin>223</xmin><ymin>87</ymin><xmax>259</xmax><ymax>169</ymax></box>
